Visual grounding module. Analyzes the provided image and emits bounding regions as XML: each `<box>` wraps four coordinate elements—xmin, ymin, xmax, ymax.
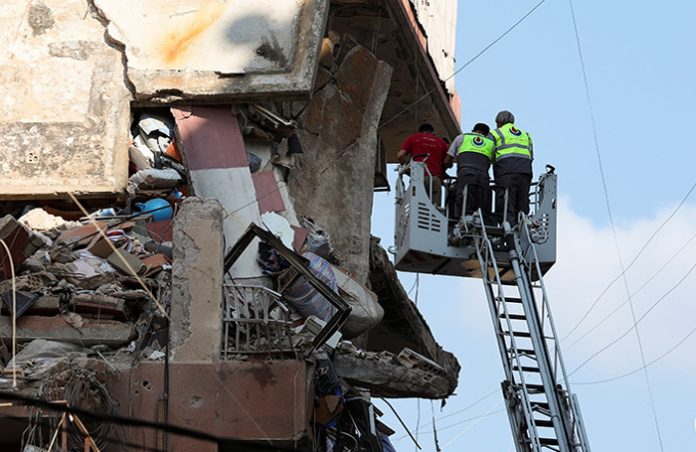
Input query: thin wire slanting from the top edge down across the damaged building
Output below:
<box><xmin>223</xmin><ymin>0</ymin><xmax>546</xmax><ymax>219</ymax></box>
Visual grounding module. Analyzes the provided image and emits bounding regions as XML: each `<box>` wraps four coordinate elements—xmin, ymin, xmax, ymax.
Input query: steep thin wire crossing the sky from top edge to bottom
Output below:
<box><xmin>568</xmin><ymin>0</ymin><xmax>665</xmax><ymax>452</ymax></box>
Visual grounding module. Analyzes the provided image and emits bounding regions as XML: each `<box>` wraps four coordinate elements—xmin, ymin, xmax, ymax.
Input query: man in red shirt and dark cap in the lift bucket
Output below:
<box><xmin>396</xmin><ymin>123</ymin><xmax>449</xmax><ymax>207</ymax></box>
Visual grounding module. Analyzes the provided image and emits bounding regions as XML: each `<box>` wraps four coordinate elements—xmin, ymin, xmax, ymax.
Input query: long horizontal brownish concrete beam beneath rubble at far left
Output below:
<box><xmin>0</xmin><ymin>315</ymin><xmax>132</xmax><ymax>347</ymax></box>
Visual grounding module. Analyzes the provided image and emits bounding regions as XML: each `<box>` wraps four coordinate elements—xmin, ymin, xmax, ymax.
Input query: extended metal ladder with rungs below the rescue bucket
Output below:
<box><xmin>465</xmin><ymin>217</ymin><xmax>590</xmax><ymax>452</ymax></box>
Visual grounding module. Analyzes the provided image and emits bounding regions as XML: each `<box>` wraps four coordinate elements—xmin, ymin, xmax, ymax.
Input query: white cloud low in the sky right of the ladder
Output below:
<box><xmin>545</xmin><ymin>198</ymin><xmax>696</xmax><ymax>379</ymax></box>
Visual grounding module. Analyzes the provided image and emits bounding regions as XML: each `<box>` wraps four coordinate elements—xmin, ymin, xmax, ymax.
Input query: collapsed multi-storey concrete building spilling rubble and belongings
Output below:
<box><xmin>0</xmin><ymin>0</ymin><xmax>459</xmax><ymax>451</ymax></box>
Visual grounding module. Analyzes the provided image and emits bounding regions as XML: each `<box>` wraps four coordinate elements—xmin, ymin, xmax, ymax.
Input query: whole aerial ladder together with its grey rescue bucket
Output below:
<box><xmin>393</xmin><ymin>162</ymin><xmax>590</xmax><ymax>452</ymax></box>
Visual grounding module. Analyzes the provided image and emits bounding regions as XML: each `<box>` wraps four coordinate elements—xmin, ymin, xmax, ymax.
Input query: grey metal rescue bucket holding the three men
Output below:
<box><xmin>392</xmin><ymin>162</ymin><xmax>557</xmax><ymax>282</ymax></box>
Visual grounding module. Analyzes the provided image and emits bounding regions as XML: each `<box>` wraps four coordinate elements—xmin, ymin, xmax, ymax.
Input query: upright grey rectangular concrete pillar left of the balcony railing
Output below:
<box><xmin>170</xmin><ymin>198</ymin><xmax>224</xmax><ymax>362</ymax></box>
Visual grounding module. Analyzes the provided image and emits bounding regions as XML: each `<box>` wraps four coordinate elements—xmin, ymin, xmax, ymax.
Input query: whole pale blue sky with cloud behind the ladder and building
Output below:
<box><xmin>373</xmin><ymin>0</ymin><xmax>696</xmax><ymax>452</ymax></box>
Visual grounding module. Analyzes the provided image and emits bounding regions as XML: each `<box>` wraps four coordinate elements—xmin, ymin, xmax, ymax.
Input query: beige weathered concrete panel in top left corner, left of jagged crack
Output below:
<box><xmin>0</xmin><ymin>0</ymin><xmax>131</xmax><ymax>199</ymax></box>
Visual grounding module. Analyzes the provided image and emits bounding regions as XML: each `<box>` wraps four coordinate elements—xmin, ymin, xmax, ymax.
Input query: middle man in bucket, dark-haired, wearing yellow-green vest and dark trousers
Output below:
<box><xmin>445</xmin><ymin>123</ymin><xmax>495</xmax><ymax>219</ymax></box>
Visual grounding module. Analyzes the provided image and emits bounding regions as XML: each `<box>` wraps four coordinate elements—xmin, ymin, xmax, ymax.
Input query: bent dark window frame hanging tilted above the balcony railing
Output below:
<box><xmin>223</xmin><ymin>223</ymin><xmax>351</xmax><ymax>354</ymax></box>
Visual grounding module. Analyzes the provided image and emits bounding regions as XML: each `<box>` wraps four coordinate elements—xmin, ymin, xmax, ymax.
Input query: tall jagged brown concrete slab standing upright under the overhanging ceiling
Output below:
<box><xmin>288</xmin><ymin>44</ymin><xmax>392</xmax><ymax>283</ymax></box>
